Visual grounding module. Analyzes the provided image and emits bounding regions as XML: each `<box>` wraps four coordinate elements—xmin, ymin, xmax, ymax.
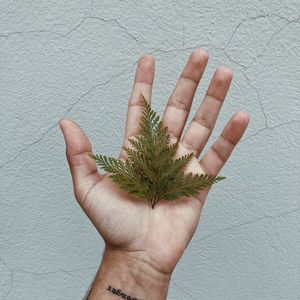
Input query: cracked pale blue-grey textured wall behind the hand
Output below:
<box><xmin>0</xmin><ymin>0</ymin><xmax>300</xmax><ymax>299</ymax></box>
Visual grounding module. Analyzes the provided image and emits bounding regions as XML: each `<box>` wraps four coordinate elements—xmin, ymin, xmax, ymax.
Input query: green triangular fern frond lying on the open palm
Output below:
<box><xmin>90</xmin><ymin>93</ymin><xmax>225</xmax><ymax>208</ymax></box>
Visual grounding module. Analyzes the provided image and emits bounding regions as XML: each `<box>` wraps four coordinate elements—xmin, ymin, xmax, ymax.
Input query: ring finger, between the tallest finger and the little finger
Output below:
<box><xmin>181</xmin><ymin>66</ymin><xmax>232</xmax><ymax>157</ymax></box>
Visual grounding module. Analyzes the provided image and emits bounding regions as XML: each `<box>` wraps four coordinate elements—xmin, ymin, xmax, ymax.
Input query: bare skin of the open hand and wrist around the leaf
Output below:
<box><xmin>60</xmin><ymin>49</ymin><xmax>249</xmax><ymax>299</ymax></box>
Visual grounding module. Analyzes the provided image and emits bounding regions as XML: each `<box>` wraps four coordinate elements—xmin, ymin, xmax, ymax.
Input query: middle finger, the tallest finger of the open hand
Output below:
<box><xmin>162</xmin><ymin>49</ymin><xmax>208</xmax><ymax>141</ymax></box>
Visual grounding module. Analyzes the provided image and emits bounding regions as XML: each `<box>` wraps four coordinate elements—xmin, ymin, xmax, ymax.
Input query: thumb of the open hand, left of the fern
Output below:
<box><xmin>59</xmin><ymin>119</ymin><xmax>102</xmax><ymax>206</ymax></box>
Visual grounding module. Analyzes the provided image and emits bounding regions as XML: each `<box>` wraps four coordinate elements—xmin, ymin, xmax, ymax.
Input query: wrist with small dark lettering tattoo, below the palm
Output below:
<box><xmin>87</xmin><ymin>248</ymin><xmax>171</xmax><ymax>300</ymax></box>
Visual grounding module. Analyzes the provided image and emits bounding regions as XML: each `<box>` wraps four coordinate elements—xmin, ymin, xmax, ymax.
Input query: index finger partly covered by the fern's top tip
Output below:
<box><xmin>124</xmin><ymin>55</ymin><xmax>155</xmax><ymax>141</ymax></box>
